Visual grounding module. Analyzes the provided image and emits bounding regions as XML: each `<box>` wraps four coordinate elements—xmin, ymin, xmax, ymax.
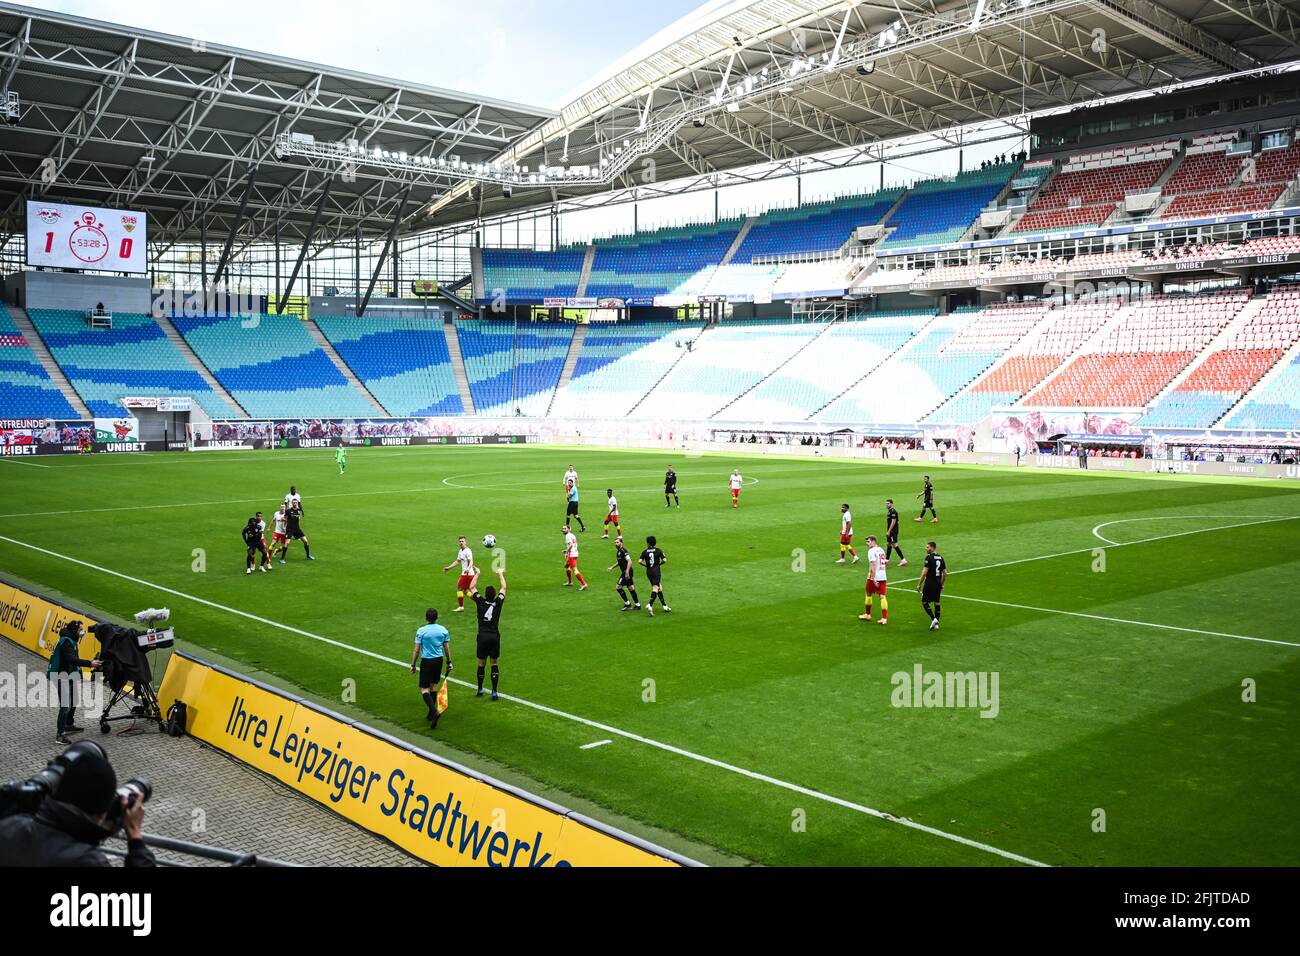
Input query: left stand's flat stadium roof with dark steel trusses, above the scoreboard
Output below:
<box><xmin>0</xmin><ymin>3</ymin><xmax>556</xmax><ymax>248</ymax></box>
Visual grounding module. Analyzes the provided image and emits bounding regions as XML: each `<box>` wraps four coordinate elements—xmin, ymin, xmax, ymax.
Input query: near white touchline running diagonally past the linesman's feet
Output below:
<box><xmin>0</xmin><ymin>535</ymin><xmax>1049</xmax><ymax>866</ymax></box>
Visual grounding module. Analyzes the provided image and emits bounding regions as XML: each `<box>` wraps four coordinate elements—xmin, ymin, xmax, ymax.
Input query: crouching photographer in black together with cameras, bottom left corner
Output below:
<box><xmin>0</xmin><ymin>740</ymin><xmax>157</xmax><ymax>866</ymax></box>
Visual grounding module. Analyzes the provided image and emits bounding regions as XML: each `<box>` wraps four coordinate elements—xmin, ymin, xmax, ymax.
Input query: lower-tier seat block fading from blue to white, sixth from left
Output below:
<box><xmin>553</xmin><ymin>320</ymin><xmax>712</xmax><ymax>418</ymax></box>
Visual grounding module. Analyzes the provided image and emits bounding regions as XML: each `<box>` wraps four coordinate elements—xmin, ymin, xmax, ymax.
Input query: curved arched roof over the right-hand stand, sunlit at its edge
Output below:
<box><xmin>410</xmin><ymin>0</ymin><xmax>1300</xmax><ymax>222</ymax></box>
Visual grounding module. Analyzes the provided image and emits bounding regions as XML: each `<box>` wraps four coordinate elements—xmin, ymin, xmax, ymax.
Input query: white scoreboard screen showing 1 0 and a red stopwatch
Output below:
<box><xmin>27</xmin><ymin>200</ymin><xmax>148</xmax><ymax>273</ymax></box>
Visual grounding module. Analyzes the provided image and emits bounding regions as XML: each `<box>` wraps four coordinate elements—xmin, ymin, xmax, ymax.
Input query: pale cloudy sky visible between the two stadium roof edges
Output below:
<box><xmin>18</xmin><ymin>0</ymin><xmax>701</xmax><ymax>107</ymax></box>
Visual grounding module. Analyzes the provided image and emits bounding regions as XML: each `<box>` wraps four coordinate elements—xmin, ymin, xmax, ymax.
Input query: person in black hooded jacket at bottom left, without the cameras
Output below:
<box><xmin>0</xmin><ymin>741</ymin><xmax>157</xmax><ymax>866</ymax></box>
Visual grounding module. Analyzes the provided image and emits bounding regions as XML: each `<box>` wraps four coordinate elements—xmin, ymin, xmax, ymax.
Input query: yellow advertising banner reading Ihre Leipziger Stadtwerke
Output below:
<box><xmin>159</xmin><ymin>653</ymin><xmax>689</xmax><ymax>868</ymax></box>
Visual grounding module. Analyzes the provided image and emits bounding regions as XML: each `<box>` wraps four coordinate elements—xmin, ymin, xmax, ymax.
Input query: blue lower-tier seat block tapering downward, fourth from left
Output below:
<box><xmin>316</xmin><ymin>313</ymin><xmax>464</xmax><ymax>416</ymax></box>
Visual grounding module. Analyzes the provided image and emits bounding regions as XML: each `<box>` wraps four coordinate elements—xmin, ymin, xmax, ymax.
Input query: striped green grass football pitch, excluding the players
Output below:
<box><xmin>0</xmin><ymin>446</ymin><xmax>1300</xmax><ymax>866</ymax></box>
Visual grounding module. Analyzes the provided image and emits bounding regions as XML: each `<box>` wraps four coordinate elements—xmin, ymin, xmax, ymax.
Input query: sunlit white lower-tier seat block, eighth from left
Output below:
<box><xmin>719</xmin><ymin>311</ymin><xmax>935</xmax><ymax>421</ymax></box>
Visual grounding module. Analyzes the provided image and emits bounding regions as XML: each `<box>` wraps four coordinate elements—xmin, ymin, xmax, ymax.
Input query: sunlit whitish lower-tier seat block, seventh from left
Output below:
<box><xmin>640</xmin><ymin>320</ymin><xmax>826</xmax><ymax>419</ymax></box>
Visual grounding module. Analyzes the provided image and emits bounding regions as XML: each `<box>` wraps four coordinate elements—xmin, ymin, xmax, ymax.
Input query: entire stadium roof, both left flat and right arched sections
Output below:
<box><xmin>0</xmin><ymin>0</ymin><xmax>1300</xmax><ymax>251</ymax></box>
